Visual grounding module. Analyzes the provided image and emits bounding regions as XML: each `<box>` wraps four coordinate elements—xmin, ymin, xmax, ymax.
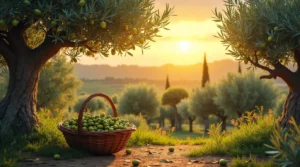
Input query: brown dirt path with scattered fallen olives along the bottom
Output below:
<box><xmin>20</xmin><ymin>146</ymin><xmax>231</xmax><ymax>167</ymax></box>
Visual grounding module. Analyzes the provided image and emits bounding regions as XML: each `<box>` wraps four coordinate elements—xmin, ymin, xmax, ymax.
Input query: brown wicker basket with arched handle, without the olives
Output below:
<box><xmin>58</xmin><ymin>93</ymin><xmax>136</xmax><ymax>155</ymax></box>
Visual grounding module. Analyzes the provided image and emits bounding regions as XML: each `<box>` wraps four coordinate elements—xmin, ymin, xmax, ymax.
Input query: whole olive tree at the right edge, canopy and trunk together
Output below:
<box><xmin>214</xmin><ymin>0</ymin><xmax>300</xmax><ymax>127</ymax></box>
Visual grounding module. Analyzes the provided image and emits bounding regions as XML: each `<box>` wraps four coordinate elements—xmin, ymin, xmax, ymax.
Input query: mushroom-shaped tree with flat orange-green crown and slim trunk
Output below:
<box><xmin>162</xmin><ymin>88</ymin><xmax>188</xmax><ymax>130</ymax></box>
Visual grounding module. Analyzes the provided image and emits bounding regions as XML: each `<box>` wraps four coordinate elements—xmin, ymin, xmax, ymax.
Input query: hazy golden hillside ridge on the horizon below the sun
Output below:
<box><xmin>75</xmin><ymin>60</ymin><xmax>246</xmax><ymax>82</ymax></box>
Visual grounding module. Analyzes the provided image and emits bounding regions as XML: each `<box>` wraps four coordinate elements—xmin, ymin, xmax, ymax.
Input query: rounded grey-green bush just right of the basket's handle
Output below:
<box><xmin>118</xmin><ymin>84</ymin><xmax>159</xmax><ymax>118</ymax></box>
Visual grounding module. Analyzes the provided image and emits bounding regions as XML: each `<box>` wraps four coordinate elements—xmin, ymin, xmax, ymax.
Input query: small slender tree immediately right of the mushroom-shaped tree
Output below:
<box><xmin>177</xmin><ymin>99</ymin><xmax>196</xmax><ymax>132</ymax></box>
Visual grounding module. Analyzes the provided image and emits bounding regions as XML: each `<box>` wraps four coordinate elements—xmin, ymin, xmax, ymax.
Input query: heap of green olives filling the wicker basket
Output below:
<box><xmin>63</xmin><ymin>114</ymin><xmax>132</xmax><ymax>132</ymax></box>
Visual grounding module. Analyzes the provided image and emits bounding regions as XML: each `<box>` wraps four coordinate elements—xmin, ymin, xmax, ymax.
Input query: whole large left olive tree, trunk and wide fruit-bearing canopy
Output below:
<box><xmin>0</xmin><ymin>0</ymin><xmax>173</xmax><ymax>133</ymax></box>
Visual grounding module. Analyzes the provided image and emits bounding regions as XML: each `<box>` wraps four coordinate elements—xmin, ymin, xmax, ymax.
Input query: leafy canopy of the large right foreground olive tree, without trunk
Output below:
<box><xmin>214</xmin><ymin>0</ymin><xmax>300</xmax><ymax>65</ymax></box>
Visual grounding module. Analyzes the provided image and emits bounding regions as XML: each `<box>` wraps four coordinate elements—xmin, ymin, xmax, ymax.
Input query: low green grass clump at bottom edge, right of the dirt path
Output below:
<box><xmin>229</xmin><ymin>155</ymin><xmax>276</xmax><ymax>167</ymax></box>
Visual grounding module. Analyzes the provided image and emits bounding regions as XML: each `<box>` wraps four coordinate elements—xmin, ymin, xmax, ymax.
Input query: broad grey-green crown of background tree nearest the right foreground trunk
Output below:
<box><xmin>215</xmin><ymin>72</ymin><xmax>278</xmax><ymax>115</ymax></box>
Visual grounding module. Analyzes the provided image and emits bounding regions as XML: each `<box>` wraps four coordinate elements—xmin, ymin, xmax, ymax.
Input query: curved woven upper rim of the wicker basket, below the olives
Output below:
<box><xmin>58</xmin><ymin>120</ymin><xmax>136</xmax><ymax>136</ymax></box>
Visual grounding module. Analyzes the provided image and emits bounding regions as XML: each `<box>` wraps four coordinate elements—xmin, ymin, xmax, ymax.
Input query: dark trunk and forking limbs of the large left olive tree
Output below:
<box><xmin>0</xmin><ymin>26</ymin><xmax>61</xmax><ymax>134</ymax></box>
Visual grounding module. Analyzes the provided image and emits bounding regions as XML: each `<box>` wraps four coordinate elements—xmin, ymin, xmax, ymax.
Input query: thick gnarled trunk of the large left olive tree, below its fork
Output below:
<box><xmin>0</xmin><ymin>54</ymin><xmax>41</xmax><ymax>133</ymax></box>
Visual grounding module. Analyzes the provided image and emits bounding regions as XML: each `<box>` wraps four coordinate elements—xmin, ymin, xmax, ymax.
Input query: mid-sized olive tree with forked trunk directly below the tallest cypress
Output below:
<box><xmin>190</xmin><ymin>84</ymin><xmax>228</xmax><ymax>133</ymax></box>
